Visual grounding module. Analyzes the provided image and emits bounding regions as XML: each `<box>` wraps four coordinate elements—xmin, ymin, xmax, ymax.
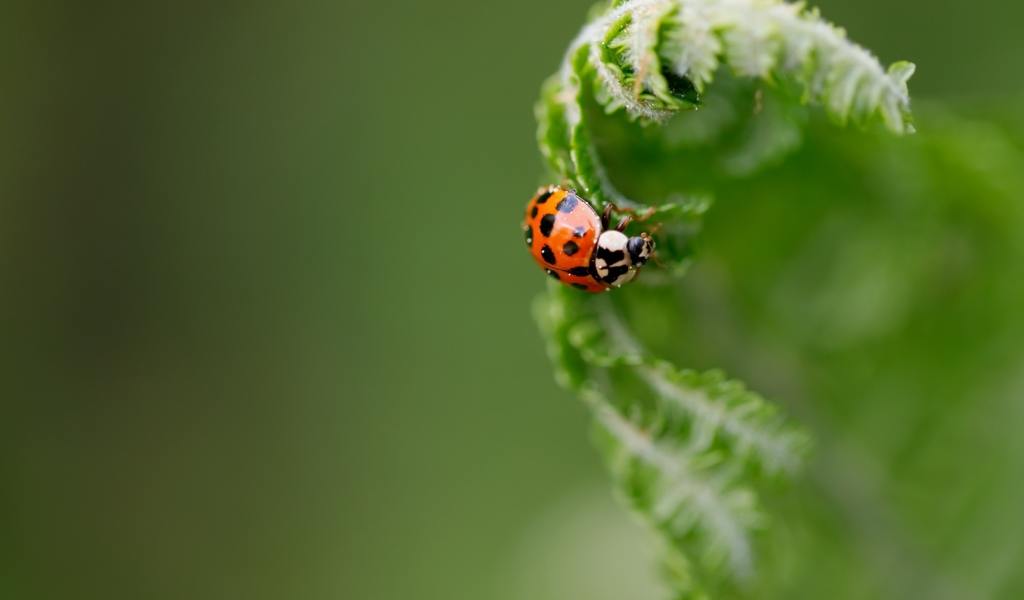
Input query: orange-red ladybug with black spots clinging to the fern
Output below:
<box><xmin>522</xmin><ymin>185</ymin><xmax>654</xmax><ymax>293</ymax></box>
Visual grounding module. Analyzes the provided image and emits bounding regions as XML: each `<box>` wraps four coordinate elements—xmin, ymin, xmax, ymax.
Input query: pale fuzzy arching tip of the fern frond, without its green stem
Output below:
<box><xmin>577</xmin><ymin>0</ymin><xmax>913</xmax><ymax>133</ymax></box>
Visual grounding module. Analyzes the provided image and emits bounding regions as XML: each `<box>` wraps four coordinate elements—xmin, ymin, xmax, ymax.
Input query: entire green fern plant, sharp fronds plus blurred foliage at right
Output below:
<box><xmin>535</xmin><ymin>0</ymin><xmax>1024</xmax><ymax>600</ymax></box>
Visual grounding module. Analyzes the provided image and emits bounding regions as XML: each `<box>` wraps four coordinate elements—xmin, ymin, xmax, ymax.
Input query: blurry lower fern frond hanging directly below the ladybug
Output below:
<box><xmin>535</xmin><ymin>285</ymin><xmax>808</xmax><ymax>593</ymax></box>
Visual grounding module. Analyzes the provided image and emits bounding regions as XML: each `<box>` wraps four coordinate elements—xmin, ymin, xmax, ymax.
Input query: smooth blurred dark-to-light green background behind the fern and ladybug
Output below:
<box><xmin>0</xmin><ymin>0</ymin><xmax>1024</xmax><ymax>600</ymax></box>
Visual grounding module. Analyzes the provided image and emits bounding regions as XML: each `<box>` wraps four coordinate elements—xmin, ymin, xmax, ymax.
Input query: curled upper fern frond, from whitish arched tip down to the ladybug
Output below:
<box><xmin>538</xmin><ymin>0</ymin><xmax>914</xmax><ymax>206</ymax></box>
